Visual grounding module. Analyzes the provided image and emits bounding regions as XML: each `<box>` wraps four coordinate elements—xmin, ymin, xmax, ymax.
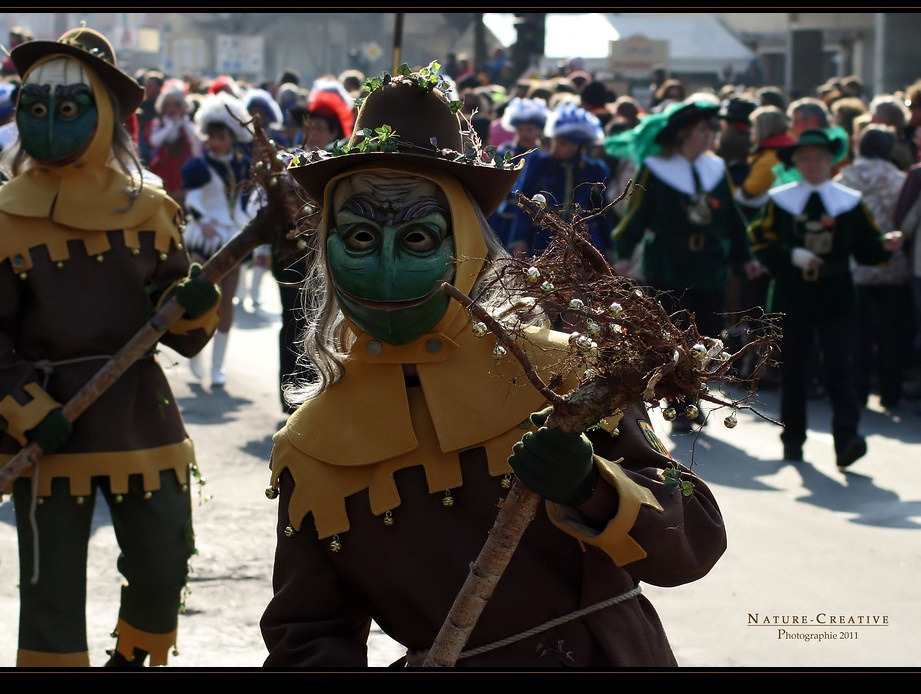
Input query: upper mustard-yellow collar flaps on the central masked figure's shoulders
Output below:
<box><xmin>281</xmin><ymin>319</ymin><xmax>569</xmax><ymax>466</ymax></box>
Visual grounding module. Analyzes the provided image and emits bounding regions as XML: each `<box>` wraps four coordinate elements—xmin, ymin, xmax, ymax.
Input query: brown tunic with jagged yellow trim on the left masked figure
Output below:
<box><xmin>0</xmin><ymin>188</ymin><xmax>214</xmax><ymax>495</ymax></box>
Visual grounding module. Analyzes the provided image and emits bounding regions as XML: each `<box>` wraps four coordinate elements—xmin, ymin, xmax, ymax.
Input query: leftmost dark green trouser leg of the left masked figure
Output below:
<box><xmin>13</xmin><ymin>478</ymin><xmax>96</xmax><ymax>654</ymax></box>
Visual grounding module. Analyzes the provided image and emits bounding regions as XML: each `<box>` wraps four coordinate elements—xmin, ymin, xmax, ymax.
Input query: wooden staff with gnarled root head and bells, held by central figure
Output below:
<box><xmin>422</xmin><ymin>192</ymin><xmax>779</xmax><ymax>667</ymax></box>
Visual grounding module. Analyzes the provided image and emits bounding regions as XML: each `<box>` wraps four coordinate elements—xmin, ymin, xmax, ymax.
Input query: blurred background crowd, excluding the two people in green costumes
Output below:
<box><xmin>0</xmin><ymin>12</ymin><xmax>921</xmax><ymax>424</ymax></box>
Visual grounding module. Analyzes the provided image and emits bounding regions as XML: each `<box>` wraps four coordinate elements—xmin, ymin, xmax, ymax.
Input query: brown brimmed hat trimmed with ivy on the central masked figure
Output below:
<box><xmin>288</xmin><ymin>63</ymin><xmax>523</xmax><ymax>216</ymax></box>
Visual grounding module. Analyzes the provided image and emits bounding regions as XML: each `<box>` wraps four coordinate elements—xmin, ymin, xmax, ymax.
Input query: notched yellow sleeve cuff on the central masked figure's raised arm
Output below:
<box><xmin>546</xmin><ymin>455</ymin><xmax>664</xmax><ymax>566</ymax></box>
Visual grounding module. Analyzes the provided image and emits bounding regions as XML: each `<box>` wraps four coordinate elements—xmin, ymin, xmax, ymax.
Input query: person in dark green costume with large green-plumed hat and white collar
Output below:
<box><xmin>605</xmin><ymin>95</ymin><xmax>762</xmax><ymax>432</ymax></box>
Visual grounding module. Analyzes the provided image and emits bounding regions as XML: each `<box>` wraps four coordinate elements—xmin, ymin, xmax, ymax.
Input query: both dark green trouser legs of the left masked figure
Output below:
<box><xmin>14</xmin><ymin>470</ymin><xmax>194</xmax><ymax>660</ymax></box>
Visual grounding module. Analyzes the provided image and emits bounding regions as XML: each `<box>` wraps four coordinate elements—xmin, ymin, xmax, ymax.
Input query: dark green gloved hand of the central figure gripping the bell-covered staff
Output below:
<box><xmin>508</xmin><ymin>407</ymin><xmax>598</xmax><ymax>506</ymax></box>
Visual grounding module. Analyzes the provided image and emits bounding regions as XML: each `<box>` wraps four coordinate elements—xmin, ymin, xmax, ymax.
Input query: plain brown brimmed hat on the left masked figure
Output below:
<box><xmin>10</xmin><ymin>27</ymin><xmax>144</xmax><ymax>118</ymax></box>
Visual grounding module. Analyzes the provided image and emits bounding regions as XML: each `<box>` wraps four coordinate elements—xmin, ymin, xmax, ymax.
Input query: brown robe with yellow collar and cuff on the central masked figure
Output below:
<box><xmin>261</xmin><ymin>320</ymin><xmax>726</xmax><ymax>668</ymax></box>
